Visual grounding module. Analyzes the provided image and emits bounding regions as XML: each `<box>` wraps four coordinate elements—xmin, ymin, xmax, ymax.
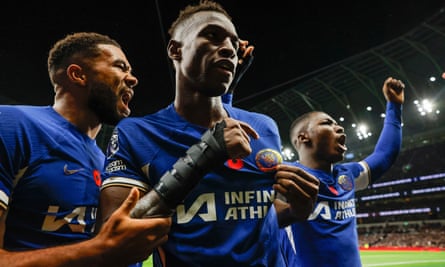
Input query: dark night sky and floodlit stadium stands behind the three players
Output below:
<box><xmin>0</xmin><ymin>0</ymin><xmax>445</xmax><ymax>266</ymax></box>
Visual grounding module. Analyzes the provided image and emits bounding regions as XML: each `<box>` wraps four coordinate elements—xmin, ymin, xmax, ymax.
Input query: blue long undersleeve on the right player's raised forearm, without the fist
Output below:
<box><xmin>365</xmin><ymin>102</ymin><xmax>402</xmax><ymax>181</ymax></box>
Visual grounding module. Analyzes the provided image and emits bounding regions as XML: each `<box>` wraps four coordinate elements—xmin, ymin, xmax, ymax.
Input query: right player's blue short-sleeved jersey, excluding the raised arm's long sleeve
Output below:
<box><xmin>288</xmin><ymin>162</ymin><xmax>369</xmax><ymax>267</ymax></box>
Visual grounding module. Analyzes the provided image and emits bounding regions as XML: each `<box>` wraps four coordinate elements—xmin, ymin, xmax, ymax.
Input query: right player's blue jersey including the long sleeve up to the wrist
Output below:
<box><xmin>283</xmin><ymin>102</ymin><xmax>402</xmax><ymax>267</ymax></box>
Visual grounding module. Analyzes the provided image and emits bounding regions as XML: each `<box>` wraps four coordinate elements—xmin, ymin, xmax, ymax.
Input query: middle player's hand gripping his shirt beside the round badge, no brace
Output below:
<box><xmin>273</xmin><ymin>164</ymin><xmax>320</xmax><ymax>221</ymax></box>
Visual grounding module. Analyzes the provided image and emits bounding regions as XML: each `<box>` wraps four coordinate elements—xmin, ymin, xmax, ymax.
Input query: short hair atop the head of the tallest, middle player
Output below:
<box><xmin>168</xmin><ymin>0</ymin><xmax>232</xmax><ymax>36</ymax></box>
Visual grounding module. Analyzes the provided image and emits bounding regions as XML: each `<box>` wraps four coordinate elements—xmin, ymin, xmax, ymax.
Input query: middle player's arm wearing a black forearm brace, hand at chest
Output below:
<box><xmin>99</xmin><ymin>118</ymin><xmax>259</xmax><ymax>221</ymax></box>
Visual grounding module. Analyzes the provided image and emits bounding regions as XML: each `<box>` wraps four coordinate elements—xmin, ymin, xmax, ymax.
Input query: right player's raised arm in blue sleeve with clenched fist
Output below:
<box><xmin>362</xmin><ymin>77</ymin><xmax>405</xmax><ymax>186</ymax></box>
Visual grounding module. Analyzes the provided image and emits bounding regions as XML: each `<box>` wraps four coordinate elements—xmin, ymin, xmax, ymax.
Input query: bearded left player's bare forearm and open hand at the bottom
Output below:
<box><xmin>0</xmin><ymin>189</ymin><xmax>171</xmax><ymax>267</ymax></box>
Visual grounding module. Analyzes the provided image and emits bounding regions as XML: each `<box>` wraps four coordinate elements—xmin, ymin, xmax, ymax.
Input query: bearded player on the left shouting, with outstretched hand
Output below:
<box><xmin>0</xmin><ymin>32</ymin><xmax>171</xmax><ymax>267</ymax></box>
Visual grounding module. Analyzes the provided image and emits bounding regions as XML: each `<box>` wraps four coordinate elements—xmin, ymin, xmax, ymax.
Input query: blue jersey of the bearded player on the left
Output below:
<box><xmin>0</xmin><ymin>106</ymin><xmax>105</xmax><ymax>250</ymax></box>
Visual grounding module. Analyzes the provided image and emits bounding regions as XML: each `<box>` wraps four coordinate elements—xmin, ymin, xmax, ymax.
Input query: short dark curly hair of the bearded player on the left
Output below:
<box><xmin>47</xmin><ymin>32</ymin><xmax>121</xmax><ymax>81</ymax></box>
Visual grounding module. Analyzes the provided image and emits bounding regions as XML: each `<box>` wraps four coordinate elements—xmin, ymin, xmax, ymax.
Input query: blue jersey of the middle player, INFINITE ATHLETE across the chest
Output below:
<box><xmin>103</xmin><ymin>104</ymin><xmax>285</xmax><ymax>267</ymax></box>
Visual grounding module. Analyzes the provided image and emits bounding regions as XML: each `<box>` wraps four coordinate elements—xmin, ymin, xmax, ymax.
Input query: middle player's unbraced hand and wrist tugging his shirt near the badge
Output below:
<box><xmin>273</xmin><ymin>164</ymin><xmax>320</xmax><ymax>227</ymax></box>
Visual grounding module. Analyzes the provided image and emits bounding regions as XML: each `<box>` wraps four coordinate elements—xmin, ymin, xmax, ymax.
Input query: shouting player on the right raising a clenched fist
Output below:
<box><xmin>277</xmin><ymin>77</ymin><xmax>405</xmax><ymax>267</ymax></box>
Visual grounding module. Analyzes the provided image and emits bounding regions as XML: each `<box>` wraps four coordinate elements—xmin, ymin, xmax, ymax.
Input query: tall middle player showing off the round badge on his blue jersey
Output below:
<box><xmin>101</xmin><ymin>1</ymin><xmax>318</xmax><ymax>267</ymax></box>
